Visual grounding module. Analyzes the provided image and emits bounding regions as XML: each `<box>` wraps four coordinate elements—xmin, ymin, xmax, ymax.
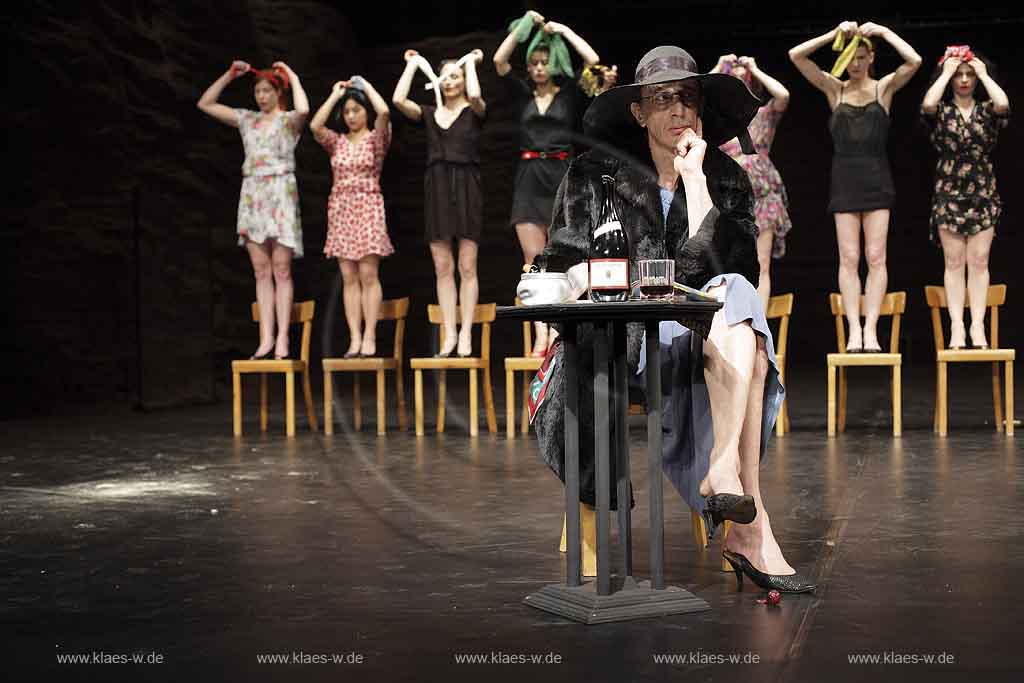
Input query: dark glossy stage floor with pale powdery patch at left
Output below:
<box><xmin>0</xmin><ymin>368</ymin><xmax>1024</xmax><ymax>683</ymax></box>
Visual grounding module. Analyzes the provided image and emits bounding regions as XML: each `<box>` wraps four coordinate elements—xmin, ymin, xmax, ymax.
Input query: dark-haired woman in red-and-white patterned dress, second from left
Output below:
<box><xmin>309</xmin><ymin>76</ymin><xmax>394</xmax><ymax>358</ymax></box>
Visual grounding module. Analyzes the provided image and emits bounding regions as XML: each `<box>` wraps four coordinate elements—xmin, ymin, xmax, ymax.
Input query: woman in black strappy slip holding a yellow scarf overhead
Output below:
<box><xmin>790</xmin><ymin>22</ymin><xmax>921</xmax><ymax>352</ymax></box>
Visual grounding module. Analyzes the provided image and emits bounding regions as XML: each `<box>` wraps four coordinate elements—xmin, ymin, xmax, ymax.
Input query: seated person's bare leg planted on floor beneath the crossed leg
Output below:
<box><xmin>724</xmin><ymin>337</ymin><xmax>795</xmax><ymax>574</ymax></box>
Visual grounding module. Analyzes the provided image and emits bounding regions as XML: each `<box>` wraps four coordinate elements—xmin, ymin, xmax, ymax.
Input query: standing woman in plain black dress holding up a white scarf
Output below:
<box><xmin>391</xmin><ymin>50</ymin><xmax>486</xmax><ymax>357</ymax></box>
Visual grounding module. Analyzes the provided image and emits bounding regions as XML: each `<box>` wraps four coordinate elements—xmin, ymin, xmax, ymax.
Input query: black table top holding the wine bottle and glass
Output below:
<box><xmin>497</xmin><ymin>297</ymin><xmax>722</xmax><ymax>323</ymax></box>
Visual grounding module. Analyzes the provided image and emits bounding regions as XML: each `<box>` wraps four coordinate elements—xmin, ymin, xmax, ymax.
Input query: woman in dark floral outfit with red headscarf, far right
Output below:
<box><xmin>921</xmin><ymin>45</ymin><xmax>1010</xmax><ymax>348</ymax></box>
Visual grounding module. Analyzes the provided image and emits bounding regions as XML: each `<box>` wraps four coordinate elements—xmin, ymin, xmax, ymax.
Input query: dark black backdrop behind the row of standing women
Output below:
<box><xmin>0</xmin><ymin>0</ymin><xmax>1024</xmax><ymax>417</ymax></box>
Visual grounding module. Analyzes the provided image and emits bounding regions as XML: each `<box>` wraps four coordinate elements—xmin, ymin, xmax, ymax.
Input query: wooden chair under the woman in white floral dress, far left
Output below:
<box><xmin>231</xmin><ymin>301</ymin><xmax>316</xmax><ymax>436</ymax></box>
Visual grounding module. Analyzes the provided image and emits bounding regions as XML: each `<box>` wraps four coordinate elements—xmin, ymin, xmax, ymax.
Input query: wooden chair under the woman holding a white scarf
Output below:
<box><xmin>409</xmin><ymin>303</ymin><xmax>498</xmax><ymax>436</ymax></box>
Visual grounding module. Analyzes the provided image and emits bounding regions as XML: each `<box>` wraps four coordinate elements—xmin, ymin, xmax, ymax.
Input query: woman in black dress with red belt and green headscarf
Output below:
<box><xmin>495</xmin><ymin>10</ymin><xmax>598</xmax><ymax>356</ymax></box>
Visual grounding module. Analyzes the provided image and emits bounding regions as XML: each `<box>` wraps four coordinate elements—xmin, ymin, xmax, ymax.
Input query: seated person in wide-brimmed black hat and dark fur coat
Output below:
<box><xmin>534</xmin><ymin>46</ymin><xmax>814</xmax><ymax>592</ymax></box>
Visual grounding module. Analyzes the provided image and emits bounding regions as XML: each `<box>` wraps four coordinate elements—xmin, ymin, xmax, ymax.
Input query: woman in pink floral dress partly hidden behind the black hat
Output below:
<box><xmin>712</xmin><ymin>54</ymin><xmax>793</xmax><ymax>308</ymax></box>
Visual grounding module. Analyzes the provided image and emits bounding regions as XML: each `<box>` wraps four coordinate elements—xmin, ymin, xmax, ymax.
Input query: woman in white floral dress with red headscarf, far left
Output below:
<box><xmin>199</xmin><ymin>61</ymin><xmax>309</xmax><ymax>359</ymax></box>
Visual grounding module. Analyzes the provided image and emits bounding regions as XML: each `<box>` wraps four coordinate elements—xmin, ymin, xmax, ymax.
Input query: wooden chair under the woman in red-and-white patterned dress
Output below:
<box><xmin>323</xmin><ymin>297</ymin><xmax>409</xmax><ymax>434</ymax></box>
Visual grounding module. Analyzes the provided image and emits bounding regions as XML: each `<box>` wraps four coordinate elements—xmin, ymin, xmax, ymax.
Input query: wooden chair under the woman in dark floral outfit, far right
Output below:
<box><xmin>925</xmin><ymin>285</ymin><xmax>1017</xmax><ymax>436</ymax></box>
